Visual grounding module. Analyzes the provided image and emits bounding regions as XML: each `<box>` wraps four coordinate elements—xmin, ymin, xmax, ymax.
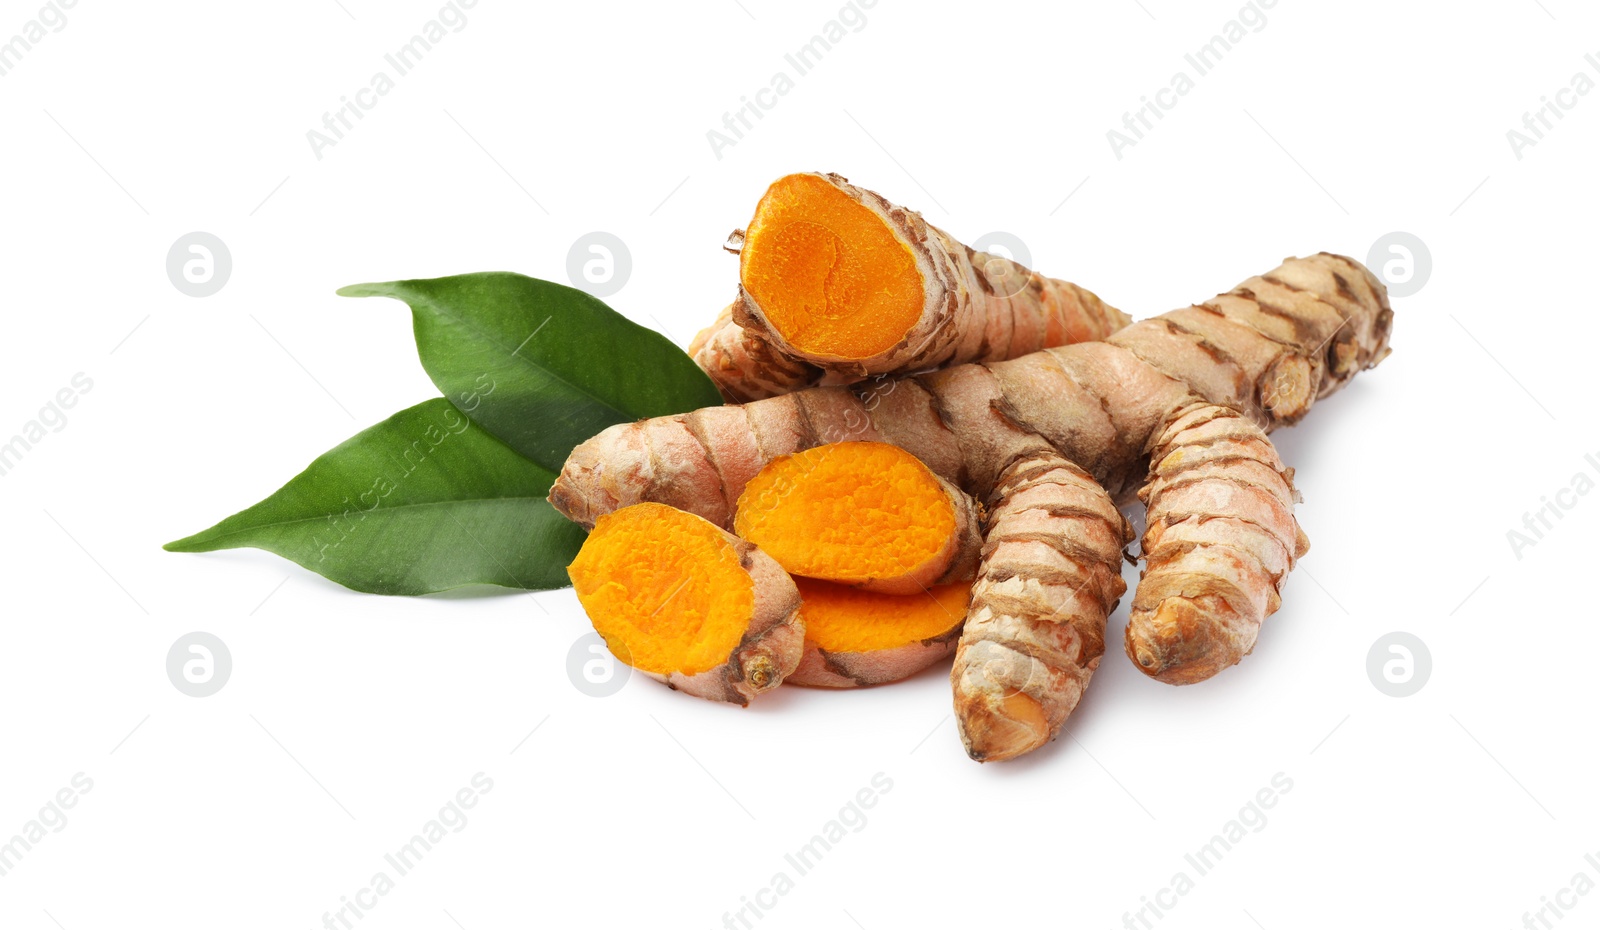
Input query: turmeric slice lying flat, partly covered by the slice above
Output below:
<box><xmin>786</xmin><ymin>578</ymin><xmax>971</xmax><ymax>688</ymax></box>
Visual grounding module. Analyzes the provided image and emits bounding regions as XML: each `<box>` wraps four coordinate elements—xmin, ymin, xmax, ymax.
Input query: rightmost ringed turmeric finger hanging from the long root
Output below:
<box><xmin>1125</xmin><ymin>403</ymin><xmax>1309</xmax><ymax>685</ymax></box>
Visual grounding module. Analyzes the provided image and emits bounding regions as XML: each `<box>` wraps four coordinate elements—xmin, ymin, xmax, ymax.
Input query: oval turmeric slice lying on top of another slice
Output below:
<box><xmin>734</xmin><ymin>442</ymin><xmax>982</xmax><ymax>594</ymax></box>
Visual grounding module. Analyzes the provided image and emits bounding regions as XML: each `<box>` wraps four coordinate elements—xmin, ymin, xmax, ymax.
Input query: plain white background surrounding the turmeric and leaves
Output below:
<box><xmin>0</xmin><ymin>0</ymin><xmax>1600</xmax><ymax>930</ymax></box>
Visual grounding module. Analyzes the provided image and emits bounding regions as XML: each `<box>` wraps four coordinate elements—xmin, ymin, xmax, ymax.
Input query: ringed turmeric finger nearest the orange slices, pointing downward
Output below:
<box><xmin>950</xmin><ymin>450</ymin><xmax>1133</xmax><ymax>762</ymax></box>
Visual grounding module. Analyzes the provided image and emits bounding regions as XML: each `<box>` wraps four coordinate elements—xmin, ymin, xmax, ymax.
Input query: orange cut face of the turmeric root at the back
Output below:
<box><xmin>739</xmin><ymin>174</ymin><xmax>926</xmax><ymax>360</ymax></box>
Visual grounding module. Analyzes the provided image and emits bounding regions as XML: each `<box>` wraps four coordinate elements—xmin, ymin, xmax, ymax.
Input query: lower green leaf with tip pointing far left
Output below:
<box><xmin>166</xmin><ymin>397</ymin><xmax>584</xmax><ymax>594</ymax></box>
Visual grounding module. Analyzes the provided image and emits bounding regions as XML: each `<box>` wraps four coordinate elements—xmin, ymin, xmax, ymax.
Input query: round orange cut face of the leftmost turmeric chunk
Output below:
<box><xmin>566</xmin><ymin>503</ymin><xmax>755</xmax><ymax>675</ymax></box>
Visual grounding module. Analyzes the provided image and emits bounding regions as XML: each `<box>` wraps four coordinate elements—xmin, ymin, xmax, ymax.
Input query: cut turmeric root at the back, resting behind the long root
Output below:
<box><xmin>690</xmin><ymin>174</ymin><xmax>1130</xmax><ymax>402</ymax></box>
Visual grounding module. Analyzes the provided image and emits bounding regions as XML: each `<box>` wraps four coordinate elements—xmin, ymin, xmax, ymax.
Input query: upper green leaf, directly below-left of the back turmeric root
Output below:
<box><xmin>339</xmin><ymin>272</ymin><xmax>722</xmax><ymax>472</ymax></box>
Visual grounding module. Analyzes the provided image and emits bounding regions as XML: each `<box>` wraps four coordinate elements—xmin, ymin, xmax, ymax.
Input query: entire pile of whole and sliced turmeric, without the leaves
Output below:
<box><xmin>550</xmin><ymin>174</ymin><xmax>1394</xmax><ymax>762</ymax></box>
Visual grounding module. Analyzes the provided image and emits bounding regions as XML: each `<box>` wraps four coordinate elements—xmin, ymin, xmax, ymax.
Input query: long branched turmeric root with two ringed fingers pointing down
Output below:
<box><xmin>550</xmin><ymin>253</ymin><xmax>1394</xmax><ymax>759</ymax></box>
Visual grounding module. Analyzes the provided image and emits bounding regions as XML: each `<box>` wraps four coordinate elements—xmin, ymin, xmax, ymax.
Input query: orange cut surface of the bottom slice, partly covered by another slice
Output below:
<box><xmin>795</xmin><ymin>578</ymin><xmax>973</xmax><ymax>653</ymax></box>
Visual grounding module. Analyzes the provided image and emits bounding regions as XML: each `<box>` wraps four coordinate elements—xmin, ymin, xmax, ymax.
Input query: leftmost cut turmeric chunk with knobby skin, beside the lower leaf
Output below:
<box><xmin>566</xmin><ymin>503</ymin><xmax>805</xmax><ymax>706</ymax></box>
